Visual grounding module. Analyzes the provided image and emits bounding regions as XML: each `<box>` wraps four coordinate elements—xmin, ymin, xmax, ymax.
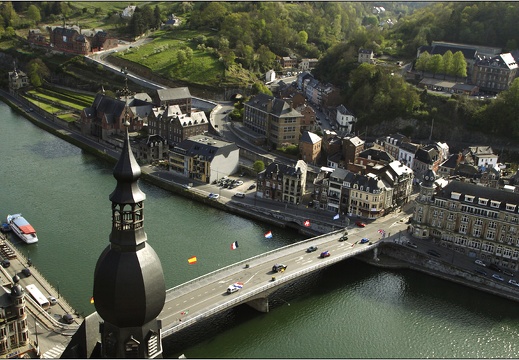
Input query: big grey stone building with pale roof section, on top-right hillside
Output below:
<box><xmin>472</xmin><ymin>53</ymin><xmax>518</xmax><ymax>93</ymax></box>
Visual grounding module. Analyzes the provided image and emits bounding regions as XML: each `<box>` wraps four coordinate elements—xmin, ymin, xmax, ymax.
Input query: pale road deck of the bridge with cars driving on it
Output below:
<box><xmin>159</xmin><ymin>212</ymin><xmax>409</xmax><ymax>336</ymax></box>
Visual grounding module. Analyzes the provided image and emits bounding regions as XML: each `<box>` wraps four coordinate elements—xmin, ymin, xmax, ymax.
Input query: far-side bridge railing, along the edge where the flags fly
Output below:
<box><xmin>166</xmin><ymin>229</ymin><xmax>344</xmax><ymax>300</ymax></box>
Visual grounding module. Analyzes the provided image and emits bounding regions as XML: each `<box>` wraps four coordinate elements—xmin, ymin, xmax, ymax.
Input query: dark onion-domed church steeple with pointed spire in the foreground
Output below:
<box><xmin>94</xmin><ymin>76</ymin><xmax>166</xmax><ymax>358</ymax></box>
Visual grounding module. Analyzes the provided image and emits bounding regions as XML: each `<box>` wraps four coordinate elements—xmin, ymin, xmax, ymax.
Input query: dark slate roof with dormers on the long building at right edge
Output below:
<box><xmin>436</xmin><ymin>181</ymin><xmax>519</xmax><ymax>213</ymax></box>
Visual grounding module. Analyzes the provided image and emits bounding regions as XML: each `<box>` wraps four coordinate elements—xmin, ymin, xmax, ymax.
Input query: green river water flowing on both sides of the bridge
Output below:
<box><xmin>0</xmin><ymin>103</ymin><xmax>519</xmax><ymax>358</ymax></box>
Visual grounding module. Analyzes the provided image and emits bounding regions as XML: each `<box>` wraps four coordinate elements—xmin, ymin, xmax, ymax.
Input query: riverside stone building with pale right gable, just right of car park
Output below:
<box><xmin>256</xmin><ymin>160</ymin><xmax>307</xmax><ymax>204</ymax></box>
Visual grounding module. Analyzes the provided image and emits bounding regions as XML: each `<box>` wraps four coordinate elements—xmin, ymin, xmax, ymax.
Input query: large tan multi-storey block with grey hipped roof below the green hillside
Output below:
<box><xmin>243</xmin><ymin>94</ymin><xmax>303</xmax><ymax>148</ymax></box>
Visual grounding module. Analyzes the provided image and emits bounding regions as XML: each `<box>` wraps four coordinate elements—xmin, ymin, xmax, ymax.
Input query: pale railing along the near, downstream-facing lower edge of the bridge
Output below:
<box><xmin>161</xmin><ymin>238</ymin><xmax>376</xmax><ymax>337</ymax></box>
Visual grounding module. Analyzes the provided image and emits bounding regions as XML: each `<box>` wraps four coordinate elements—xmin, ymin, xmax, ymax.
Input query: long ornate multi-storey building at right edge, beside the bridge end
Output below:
<box><xmin>411</xmin><ymin>171</ymin><xmax>519</xmax><ymax>270</ymax></box>
